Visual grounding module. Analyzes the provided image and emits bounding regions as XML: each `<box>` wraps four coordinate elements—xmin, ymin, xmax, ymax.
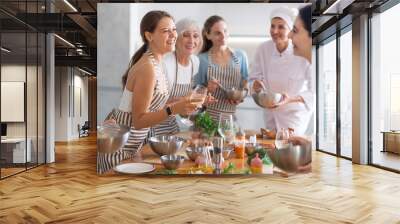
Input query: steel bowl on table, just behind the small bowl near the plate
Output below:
<box><xmin>149</xmin><ymin>135</ymin><xmax>185</xmax><ymax>156</ymax></box>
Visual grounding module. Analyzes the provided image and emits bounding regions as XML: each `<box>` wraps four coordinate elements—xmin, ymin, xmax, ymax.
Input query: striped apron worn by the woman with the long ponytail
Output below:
<box><xmin>97</xmin><ymin>51</ymin><xmax>169</xmax><ymax>174</ymax></box>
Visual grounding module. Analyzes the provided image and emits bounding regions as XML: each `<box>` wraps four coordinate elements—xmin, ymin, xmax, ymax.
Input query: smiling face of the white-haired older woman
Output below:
<box><xmin>176</xmin><ymin>27</ymin><xmax>201</xmax><ymax>56</ymax></box>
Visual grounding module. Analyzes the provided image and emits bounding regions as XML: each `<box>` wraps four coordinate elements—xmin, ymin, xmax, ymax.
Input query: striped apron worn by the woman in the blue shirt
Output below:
<box><xmin>207</xmin><ymin>50</ymin><xmax>242</xmax><ymax>122</ymax></box>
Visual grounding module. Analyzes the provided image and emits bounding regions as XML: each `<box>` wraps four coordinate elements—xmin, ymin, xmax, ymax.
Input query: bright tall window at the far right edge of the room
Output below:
<box><xmin>370</xmin><ymin>1</ymin><xmax>400</xmax><ymax>170</ymax></box>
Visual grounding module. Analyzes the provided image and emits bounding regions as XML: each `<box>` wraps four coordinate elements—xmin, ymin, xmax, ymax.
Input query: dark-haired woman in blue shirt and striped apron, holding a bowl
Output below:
<box><xmin>195</xmin><ymin>15</ymin><xmax>248</xmax><ymax>120</ymax></box>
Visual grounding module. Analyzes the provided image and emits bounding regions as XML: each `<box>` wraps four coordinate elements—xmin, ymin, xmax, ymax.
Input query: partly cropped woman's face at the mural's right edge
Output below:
<box><xmin>289</xmin><ymin>18</ymin><xmax>312</xmax><ymax>58</ymax></box>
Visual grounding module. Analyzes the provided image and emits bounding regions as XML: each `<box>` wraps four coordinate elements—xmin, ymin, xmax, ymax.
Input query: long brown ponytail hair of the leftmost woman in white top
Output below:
<box><xmin>122</xmin><ymin>10</ymin><xmax>173</xmax><ymax>88</ymax></box>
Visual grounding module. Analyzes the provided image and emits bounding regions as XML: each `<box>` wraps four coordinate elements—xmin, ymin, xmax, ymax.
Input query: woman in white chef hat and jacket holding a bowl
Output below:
<box><xmin>250</xmin><ymin>7</ymin><xmax>314</xmax><ymax>136</ymax></box>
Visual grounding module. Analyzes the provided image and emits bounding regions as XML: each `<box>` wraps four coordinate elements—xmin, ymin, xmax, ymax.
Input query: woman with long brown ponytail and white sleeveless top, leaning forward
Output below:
<box><xmin>97</xmin><ymin>11</ymin><xmax>196</xmax><ymax>173</ymax></box>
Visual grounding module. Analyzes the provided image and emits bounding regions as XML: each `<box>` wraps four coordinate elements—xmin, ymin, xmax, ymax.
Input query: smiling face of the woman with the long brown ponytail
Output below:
<box><xmin>145</xmin><ymin>17</ymin><xmax>177</xmax><ymax>54</ymax></box>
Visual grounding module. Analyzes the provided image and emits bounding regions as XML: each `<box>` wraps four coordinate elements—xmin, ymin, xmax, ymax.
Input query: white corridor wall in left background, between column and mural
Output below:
<box><xmin>55</xmin><ymin>67</ymin><xmax>89</xmax><ymax>141</ymax></box>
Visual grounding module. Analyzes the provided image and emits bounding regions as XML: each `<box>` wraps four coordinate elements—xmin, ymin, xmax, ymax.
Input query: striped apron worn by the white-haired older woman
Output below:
<box><xmin>151</xmin><ymin>53</ymin><xmax>194</xmax><ymax>136</ymax></box>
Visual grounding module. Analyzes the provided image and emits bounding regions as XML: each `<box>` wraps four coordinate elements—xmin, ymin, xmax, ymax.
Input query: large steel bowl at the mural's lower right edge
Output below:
<box><xmin>267</xmin><ymin>143</ymin><xmax>311</xmax><ymax>172</ymax></box>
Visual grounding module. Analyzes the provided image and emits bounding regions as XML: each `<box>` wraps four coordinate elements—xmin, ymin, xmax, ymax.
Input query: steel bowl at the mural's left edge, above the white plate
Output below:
<box><xmin>97</xmin><ymin>124</ymin><xmax>130</xmax><ymax>153</ymax></box>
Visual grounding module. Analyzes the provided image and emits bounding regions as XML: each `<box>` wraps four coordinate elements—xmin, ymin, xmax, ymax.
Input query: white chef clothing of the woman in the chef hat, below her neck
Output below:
<box><xmin>249</xmin><ymin>40</ymin><xmax>315</xmax><ymax>135</ymax></box>
